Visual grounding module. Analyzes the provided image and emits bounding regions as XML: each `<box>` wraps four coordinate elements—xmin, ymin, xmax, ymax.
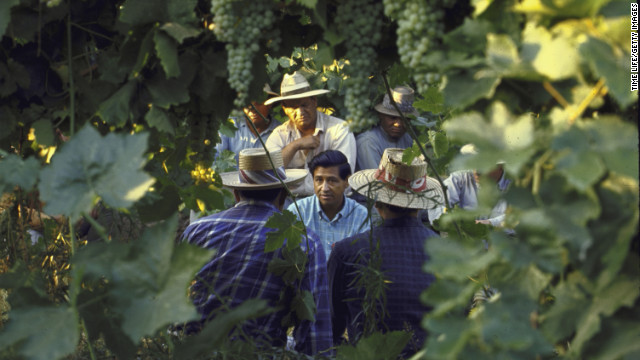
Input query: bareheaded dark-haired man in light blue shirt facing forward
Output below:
<box><xmin>287</xmin><ymin>150</ymin><xmax>369</xmax><ymax>256</ymax></box>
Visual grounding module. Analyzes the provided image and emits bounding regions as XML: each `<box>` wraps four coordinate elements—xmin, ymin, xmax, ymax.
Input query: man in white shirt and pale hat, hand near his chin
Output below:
<box><xmin>265</xmin><ymin>72</ymin><xmax>356</xmax><ymax>197</ymax></box>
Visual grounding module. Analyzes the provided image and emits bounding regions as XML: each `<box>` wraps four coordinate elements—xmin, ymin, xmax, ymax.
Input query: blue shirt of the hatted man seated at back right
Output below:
<box><xmin>356</xmin><ymin>125</ymin><xmax>413</xmax><ymax>171</ymax></box>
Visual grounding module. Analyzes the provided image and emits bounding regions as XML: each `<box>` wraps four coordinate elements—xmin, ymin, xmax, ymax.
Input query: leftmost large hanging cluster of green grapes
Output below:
<box><xmin>211</xmin><ymin>0</ymin><xmax>277</xmax><ymax>109</ymax></box>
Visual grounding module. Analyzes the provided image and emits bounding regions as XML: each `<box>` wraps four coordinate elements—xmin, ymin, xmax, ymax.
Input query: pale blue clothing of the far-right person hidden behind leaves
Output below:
<box><xmin>429</xmin><ymin>170</ymin><xmax>511</xmax><ymax>226</ymax></box>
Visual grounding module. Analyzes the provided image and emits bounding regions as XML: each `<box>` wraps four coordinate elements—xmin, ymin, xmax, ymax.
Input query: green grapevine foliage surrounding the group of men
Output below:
<box><xmin>0</xmin><ymin>0</ymin><xmax>640</xmax><ymax>359</ymax></box>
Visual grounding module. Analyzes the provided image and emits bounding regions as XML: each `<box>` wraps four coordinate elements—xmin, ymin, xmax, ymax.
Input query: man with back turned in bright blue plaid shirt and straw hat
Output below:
<box><xmin>183</xmin><ymin>149</ymin><xmax>332</xmax><ymax>355</ymax></box>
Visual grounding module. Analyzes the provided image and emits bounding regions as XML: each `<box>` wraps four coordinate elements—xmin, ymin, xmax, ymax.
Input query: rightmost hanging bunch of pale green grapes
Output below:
<box><xmin>383</xmin><ymin>0</ymin><xmax>448</xmax><ymax>92</ymax></box>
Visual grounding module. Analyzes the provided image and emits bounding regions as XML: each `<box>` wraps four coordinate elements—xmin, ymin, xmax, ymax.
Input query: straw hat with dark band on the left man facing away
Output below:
<box><xmin>220</xmin><ymin>149</ymin><xmax>309</xmax><ymax>190</ymax></box>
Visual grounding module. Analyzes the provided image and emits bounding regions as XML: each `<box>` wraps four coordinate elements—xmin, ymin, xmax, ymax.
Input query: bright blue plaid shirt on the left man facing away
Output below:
<box><xmin>183</xmin><ymin>201</ymin><xmax>333</xmax><ymax>355</ymax></box>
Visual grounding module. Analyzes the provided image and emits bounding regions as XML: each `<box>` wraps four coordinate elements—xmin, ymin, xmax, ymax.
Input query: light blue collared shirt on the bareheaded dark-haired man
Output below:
<box><xmin>287</xmin><ymin>195</ymin><xmax>370</xmax><ymax>257</ymax></box>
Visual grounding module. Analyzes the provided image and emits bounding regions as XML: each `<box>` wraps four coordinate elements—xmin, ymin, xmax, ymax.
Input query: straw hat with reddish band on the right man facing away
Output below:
<box><xmin>349</xmin><ymin>148</ymin><xmax>444</xmax><ymax>209</ymax></box>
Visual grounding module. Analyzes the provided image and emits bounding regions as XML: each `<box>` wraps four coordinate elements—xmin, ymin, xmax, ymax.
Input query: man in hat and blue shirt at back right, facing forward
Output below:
<box><xmin>356</xmin><ymin>86</ymin><xmax>418</xmax><ymax>170</ymax></box>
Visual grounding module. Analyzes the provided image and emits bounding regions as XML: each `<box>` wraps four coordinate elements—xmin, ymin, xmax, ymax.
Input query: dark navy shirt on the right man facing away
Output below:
<box><xmin>327</xmin><ymin>216</ymin><xmax>438</xmax><ymax>357</ymax></box>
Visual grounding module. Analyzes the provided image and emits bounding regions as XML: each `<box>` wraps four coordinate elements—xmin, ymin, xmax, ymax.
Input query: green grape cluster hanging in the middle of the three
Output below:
<box><xmin>335</xmin><ymin>0</ymin><xmax>383</xmax><ymax>132</ymax></box>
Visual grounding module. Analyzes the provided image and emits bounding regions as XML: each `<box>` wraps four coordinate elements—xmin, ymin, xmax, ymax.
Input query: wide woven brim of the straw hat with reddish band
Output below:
<box><xmin>349</xmin><ymin>169</ymin><xmax>444</xmax><ymax>210</ymax></box>
